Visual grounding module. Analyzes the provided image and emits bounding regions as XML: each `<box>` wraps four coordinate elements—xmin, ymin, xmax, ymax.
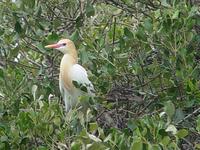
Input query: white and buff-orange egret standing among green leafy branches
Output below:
<box><xmin>45</xmin><ymin>39</ymin><xmax>94</xmax><ymax>112</ymax></box>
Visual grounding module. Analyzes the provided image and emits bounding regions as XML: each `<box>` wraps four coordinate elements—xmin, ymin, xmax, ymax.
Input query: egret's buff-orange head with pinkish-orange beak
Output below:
<box><xmin>45</xmin><ymin>39</ymin><xmax>76</xmax><ymax>54</ymax></box>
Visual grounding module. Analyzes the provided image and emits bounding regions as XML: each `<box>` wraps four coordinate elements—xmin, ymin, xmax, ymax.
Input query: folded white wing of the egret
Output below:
<box><xmin>70</xmin><ymin>64</ymin><xmax>94</xmax><ymax>96</ymax></box>
